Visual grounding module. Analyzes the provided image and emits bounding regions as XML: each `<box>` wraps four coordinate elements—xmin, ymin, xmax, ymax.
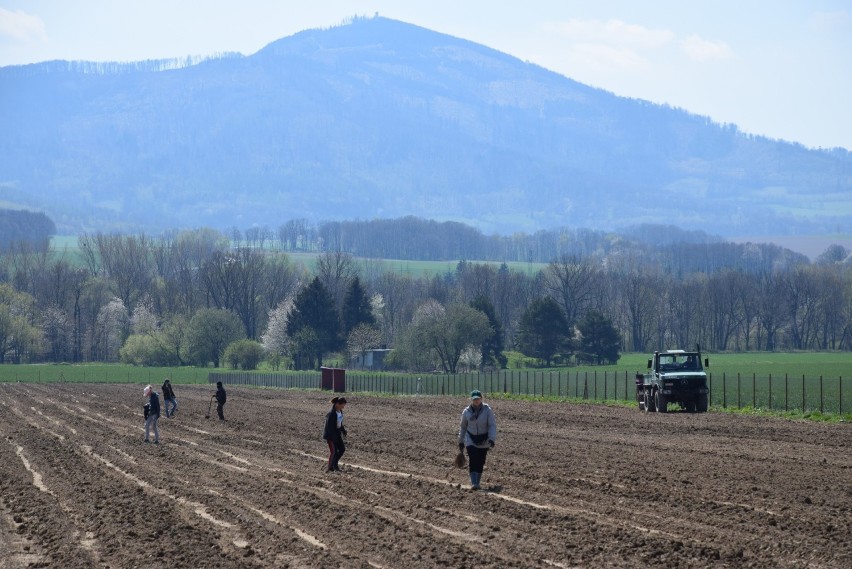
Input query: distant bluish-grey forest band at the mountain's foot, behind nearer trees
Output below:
<box><xmin>236</xmin><ymin>216</ymin><xmax>808</xmax><ymax>275</ymax></box>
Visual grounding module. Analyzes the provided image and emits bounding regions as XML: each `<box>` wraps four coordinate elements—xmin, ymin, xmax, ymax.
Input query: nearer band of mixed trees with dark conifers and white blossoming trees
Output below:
<box><xmin>0</xmin><ymin>229</ymin><xmax>852</xmax><ymax>371</ymax></box>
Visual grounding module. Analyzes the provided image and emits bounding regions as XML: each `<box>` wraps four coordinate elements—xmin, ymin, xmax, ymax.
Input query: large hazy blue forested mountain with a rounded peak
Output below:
<box><xmin>0</xmin><ymin>17</ymin><xmax>852</xmax><ymax>236</ymax></box>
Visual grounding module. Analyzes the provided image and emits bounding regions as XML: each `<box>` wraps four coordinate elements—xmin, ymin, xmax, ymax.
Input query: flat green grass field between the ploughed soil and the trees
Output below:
<box><xmin>0</xmin><ymin>352</ymin><xmax>852</xmax><ymax>417</ymax></box>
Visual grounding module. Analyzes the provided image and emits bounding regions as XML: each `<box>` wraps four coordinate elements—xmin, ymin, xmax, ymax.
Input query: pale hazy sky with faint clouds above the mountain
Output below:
<box><xmin>5</xmin><ymin>0</ymin><xmax>852</xmax><ymax>150</ymax></box>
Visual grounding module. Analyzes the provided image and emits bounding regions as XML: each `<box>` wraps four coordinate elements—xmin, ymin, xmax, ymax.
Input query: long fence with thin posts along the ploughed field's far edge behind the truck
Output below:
<box><xmin>208</xmin><ymin>370</ymin><xmax>852</xmax><ymax>414</ymax></box>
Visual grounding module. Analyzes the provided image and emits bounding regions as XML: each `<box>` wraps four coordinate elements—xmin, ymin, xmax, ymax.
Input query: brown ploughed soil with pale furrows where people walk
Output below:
<box><xmin>0</xmin><ymin>384</ymin><xmax>852</xmax><ymax>569</ymax></box>
